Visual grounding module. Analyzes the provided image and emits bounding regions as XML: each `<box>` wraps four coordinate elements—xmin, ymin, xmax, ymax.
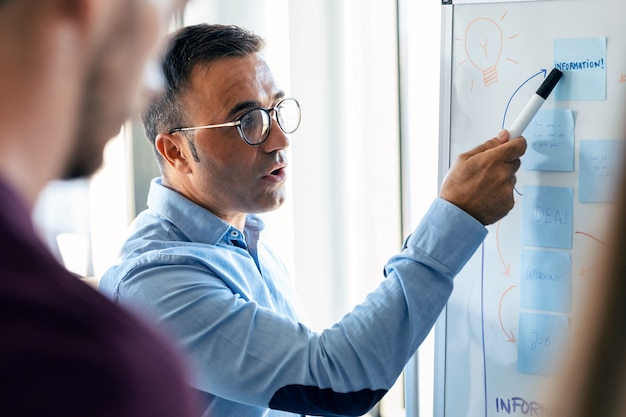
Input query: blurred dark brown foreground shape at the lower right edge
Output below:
<box><xmin>548</xmin><ymin>148</ymin><xmax>626</xmax><ymax>417</ymax></box>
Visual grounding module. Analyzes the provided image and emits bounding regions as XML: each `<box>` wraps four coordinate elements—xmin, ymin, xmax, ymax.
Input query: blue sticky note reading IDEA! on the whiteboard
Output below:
<box><xmin>521</xmin><ymin>185</ymin><xmax>574</xmax><ymax>249</ymax></box>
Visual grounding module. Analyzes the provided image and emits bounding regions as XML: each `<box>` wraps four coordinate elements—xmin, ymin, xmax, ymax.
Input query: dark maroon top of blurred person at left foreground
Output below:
<box><xmin>0</xmin><ymin>181</ymin><xmax>199</xmax><ymax>417</ymax></box>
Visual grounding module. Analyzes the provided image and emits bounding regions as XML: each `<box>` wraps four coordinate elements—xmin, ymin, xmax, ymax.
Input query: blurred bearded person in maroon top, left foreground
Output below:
<box><xmin>0</xmin><ymin>0</ymin><xmax>197</xmax><ymax>417</ymax></box>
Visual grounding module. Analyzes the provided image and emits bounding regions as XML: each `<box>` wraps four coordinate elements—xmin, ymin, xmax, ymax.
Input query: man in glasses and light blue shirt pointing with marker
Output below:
<box><xmin>100</xmin><ymin>25</ymin><xmax>526</xmax><ymax>416</ymax></box>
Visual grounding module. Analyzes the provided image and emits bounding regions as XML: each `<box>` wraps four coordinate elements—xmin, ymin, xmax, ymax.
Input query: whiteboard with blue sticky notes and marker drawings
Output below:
<box><xmin>435</xmin><ymin>0</ymin><xmax>626</xmax><ymax>417</ymax></box>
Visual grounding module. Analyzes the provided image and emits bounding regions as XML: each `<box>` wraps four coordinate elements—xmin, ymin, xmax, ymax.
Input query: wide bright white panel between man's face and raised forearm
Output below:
<box><xmin>289</xmin><ymin>0</ymin><xmax>402</xmax><ymax>327</ymax></box>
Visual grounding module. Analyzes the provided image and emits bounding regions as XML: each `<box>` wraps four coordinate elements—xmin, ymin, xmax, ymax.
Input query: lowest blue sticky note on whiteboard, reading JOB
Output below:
<box><xmin>517</xmin><ymin>312</ymin><xmax>569</xmax><ymax>375</ymax></box>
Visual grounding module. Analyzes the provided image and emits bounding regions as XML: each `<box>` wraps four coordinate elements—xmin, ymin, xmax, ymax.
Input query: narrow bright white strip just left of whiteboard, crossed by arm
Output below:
<box><xmin>399</xmin><ymin>0</ymin><xmax>441</xmax><ymax>417</ymax></box>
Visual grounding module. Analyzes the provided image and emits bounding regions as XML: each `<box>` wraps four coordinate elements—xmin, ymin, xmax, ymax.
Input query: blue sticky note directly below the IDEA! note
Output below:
<box><xmin>520</xmin><ymin>249</ymin><xmax>572</xmax><ymax>313</ymax></box>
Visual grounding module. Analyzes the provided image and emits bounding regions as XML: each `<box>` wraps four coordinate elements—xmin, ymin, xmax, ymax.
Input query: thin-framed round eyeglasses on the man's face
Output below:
<box><xmin>169</xmin><ymin>98</ymin><xmax>301</xmax><ymax>146</ymax></box>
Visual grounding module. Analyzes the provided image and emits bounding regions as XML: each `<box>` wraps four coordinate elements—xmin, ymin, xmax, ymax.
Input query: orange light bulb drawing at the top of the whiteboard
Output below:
<box><xmin>465</xmin><ymin>17</ymin><xmax>503</xmax><ymax>87</ymax></box>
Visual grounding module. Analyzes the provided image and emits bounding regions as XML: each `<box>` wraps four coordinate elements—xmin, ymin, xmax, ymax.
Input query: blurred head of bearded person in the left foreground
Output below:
<box><xmin>0</xmin><ymin>0</ymin><xmax>180</xmax><ymax>206</ymax></box>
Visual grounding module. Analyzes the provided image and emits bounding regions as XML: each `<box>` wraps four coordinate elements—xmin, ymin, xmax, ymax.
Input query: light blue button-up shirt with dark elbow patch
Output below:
<box><xmin>100</xmin><ymin>179</ymin><xmax>487</xmax><ymax>417</ymax></box>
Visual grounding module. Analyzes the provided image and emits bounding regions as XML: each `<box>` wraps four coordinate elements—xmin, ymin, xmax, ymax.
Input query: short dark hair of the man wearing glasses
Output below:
<box><xmin>142</xmin><ymin>23</ymin><xmax>265</xmax><ymax>163</ymax></box>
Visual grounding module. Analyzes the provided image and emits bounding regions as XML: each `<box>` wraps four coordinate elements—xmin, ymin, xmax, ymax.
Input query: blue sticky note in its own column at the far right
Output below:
<box><xmin>578</xmin><ymin>139</ymin><xmax>624</xmax><ymax>203</ymax></box>
